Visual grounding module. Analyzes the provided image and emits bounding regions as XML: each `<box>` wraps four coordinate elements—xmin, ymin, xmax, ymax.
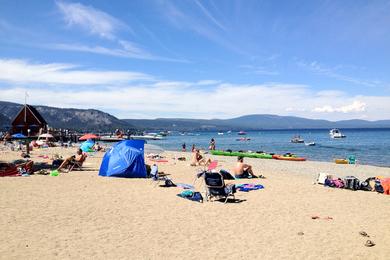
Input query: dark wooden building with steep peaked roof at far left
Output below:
<box><xmin>12</xmin><ymin>104</ymin><xmax>47</xmax><ymax>136</ymax></box>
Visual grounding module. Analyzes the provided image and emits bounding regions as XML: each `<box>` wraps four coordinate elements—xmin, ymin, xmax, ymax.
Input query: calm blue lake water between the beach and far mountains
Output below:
<box><xmin>148</xmin><ymin>129</ymin><xmax>390</xmax><ymax>167</ymax></box>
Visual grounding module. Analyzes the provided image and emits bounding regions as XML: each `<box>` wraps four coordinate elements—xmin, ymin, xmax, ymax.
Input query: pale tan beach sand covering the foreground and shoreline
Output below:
<box><xmin>0</xmin><ymin>148</ymin><xmax>390</xmax><ymax>259</ymax></box>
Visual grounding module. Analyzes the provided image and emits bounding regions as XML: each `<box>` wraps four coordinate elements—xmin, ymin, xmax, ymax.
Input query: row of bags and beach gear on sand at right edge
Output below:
<box><xmin>317</xmin><ymin>173</ymin><xmax>390</xmax><ymax>195</ymax></box>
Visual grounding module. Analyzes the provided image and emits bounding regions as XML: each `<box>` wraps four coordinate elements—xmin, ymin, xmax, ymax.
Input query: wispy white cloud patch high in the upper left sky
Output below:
<box><xmin>56</xmin><ymin>1</ymin><xmax>125</xmax><ymax>39</ymax></box>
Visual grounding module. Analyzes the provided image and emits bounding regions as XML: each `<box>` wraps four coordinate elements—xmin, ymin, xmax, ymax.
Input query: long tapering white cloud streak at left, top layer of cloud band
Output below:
<box><xmin>0</xmin><ymin>59</ymin><xmax>152</xmax><ymax>85</ymax></box>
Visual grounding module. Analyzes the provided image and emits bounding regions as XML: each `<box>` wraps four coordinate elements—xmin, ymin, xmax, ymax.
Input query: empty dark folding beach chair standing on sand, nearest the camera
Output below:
<box><xmin>203</xmin><ymin>171</ymin><xmax>236</xmax><ymax>203</ymax></box>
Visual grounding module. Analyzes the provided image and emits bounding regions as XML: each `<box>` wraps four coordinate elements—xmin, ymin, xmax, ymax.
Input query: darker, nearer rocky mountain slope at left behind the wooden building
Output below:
<box><xmin>0</xmin><ymin>101</ymin><xmax>131</xmax><ymax>131</ymax></box>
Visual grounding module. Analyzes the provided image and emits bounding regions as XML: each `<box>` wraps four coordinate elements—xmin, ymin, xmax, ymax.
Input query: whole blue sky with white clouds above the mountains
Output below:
<box><xmin>0</xmin><ymin>0</ymin><xmax>390</xmax><ymax>120</ymax></box>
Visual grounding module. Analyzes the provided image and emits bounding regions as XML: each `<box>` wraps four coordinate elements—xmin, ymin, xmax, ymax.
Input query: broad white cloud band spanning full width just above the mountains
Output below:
<box><xmin>0</xmin><ymin>59</ymin><xmax>390</xmax><ymax>120</ymax></box>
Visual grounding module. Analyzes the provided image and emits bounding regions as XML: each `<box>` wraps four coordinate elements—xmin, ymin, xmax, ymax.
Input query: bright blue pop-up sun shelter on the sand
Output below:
<box><xmin>99</xmin><ymin>140</ymin><xmax>146</xmax><ymax>178</ymax></box>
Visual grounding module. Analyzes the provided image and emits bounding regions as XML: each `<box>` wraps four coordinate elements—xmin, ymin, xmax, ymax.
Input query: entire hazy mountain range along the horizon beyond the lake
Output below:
<box><xmin>0</xmin><ymin>101</ymin><xmax>390</xmax><ymax>131</ymax></box>
